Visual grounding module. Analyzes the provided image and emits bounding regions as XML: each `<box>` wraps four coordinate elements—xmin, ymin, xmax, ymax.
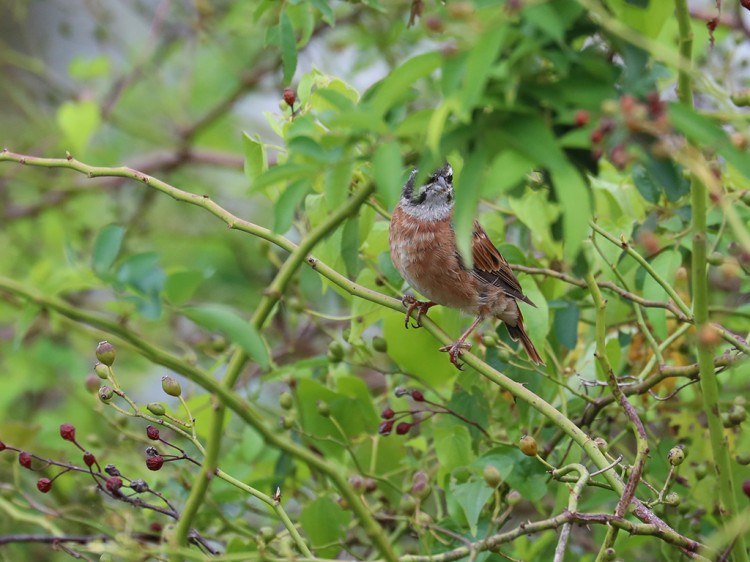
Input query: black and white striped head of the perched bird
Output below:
<box><xmin>401</xmin><ymin>162</ymin><xmax>453</xmax><ymax>221</ymax></box>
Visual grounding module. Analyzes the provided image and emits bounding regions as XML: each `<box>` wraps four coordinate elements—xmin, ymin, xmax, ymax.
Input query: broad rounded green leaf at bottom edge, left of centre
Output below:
<box><xmin>300</xmin><ymin>496</ymin><xmax>351</xmax><ymax>558</ymax></box>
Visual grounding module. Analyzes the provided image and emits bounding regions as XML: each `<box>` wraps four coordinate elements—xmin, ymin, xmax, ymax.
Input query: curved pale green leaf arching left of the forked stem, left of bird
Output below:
<box><xmin>182</xmin><ymin>304</ymin><xmax>270</xmax><ymax>369</ymax></box>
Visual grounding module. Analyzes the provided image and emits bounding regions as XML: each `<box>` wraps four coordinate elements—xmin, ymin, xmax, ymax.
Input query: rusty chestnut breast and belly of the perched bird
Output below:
<box><xmin>389</xmin><ymin>206</ymin><xmax>483</xmax><ymax>314</ymax></box>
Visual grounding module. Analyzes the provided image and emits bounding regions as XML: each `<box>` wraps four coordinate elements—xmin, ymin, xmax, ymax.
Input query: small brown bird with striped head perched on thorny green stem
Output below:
<box><xmin>388</xmin><ymin>162</ymin><xmax>544</xmax><ymax>369</ymax></box>
